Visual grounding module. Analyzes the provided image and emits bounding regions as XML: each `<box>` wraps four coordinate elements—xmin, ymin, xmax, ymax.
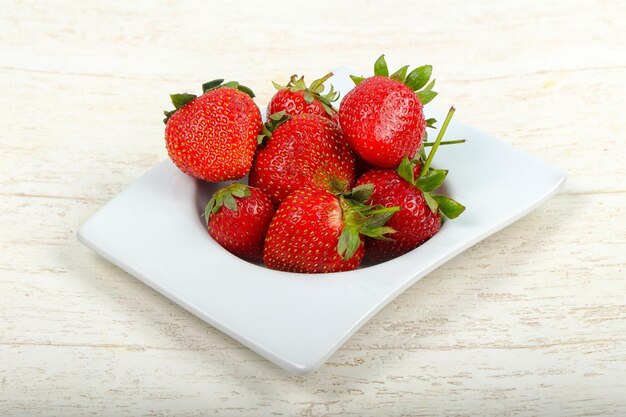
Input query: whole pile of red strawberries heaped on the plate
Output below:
<box><xmin>164</xmin><ymin>55</ymin><xmax>465</xmax><ymax>273</ymax></box>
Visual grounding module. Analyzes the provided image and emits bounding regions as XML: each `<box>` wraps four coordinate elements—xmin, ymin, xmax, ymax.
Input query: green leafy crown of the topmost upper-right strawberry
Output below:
<box><xmin>350</xmin><ymin>54</ymin><xmax>438</xmax><ymax>106</ymax></box>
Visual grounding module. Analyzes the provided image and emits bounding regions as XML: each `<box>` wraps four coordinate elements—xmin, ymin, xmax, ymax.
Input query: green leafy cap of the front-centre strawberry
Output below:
<box><xmin>337</xmin><ymin>184</ymin><xmax>400</xmax><ymax>260</ymax></box>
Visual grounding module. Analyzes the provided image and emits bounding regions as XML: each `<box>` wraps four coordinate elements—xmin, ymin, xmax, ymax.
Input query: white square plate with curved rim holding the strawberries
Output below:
<box><xmin>78</xmin><ymin>70</ymin><xmax>565</xmax><ymax>374</ymax></box>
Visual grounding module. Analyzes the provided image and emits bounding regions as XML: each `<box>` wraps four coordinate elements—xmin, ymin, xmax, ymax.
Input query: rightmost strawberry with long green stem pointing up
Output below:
<box><xmin>357</xmin><ymin>109</ymin><xmax>465</xmax><ymax>262</ymax></box>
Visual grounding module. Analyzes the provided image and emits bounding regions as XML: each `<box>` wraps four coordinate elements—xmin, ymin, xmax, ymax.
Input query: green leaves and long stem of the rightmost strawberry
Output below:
<box><xmin>397</xmin><ymin>107</ymin><xmax>465</xmax><ymax>219</ymax></box>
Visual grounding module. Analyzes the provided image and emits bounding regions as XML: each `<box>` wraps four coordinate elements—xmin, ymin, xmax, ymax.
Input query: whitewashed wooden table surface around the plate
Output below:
<box><xmin>0</xmin><ymin>0</ymin><xmax>626</xmax><ymax>416</ymax></box>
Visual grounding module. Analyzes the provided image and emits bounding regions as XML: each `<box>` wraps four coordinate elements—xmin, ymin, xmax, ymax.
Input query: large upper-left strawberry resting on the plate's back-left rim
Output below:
<box><xmin>164</xmin><ymin>80</ymin><xmax>262</xmax><ymax>182</ymax></box>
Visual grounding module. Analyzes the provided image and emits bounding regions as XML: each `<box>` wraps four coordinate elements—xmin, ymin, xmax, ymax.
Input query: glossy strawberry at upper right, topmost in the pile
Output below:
<box><xmin>339</xmin><ymin>55</ymin><xmax>437</xmax><ymax>168</ymax></box>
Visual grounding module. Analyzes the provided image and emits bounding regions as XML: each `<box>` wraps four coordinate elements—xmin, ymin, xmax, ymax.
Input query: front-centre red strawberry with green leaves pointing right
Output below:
<box><xmin>263</xmin><ymin>185</ymin><xmax>398</xmax><ymax>273</ymax></box>
